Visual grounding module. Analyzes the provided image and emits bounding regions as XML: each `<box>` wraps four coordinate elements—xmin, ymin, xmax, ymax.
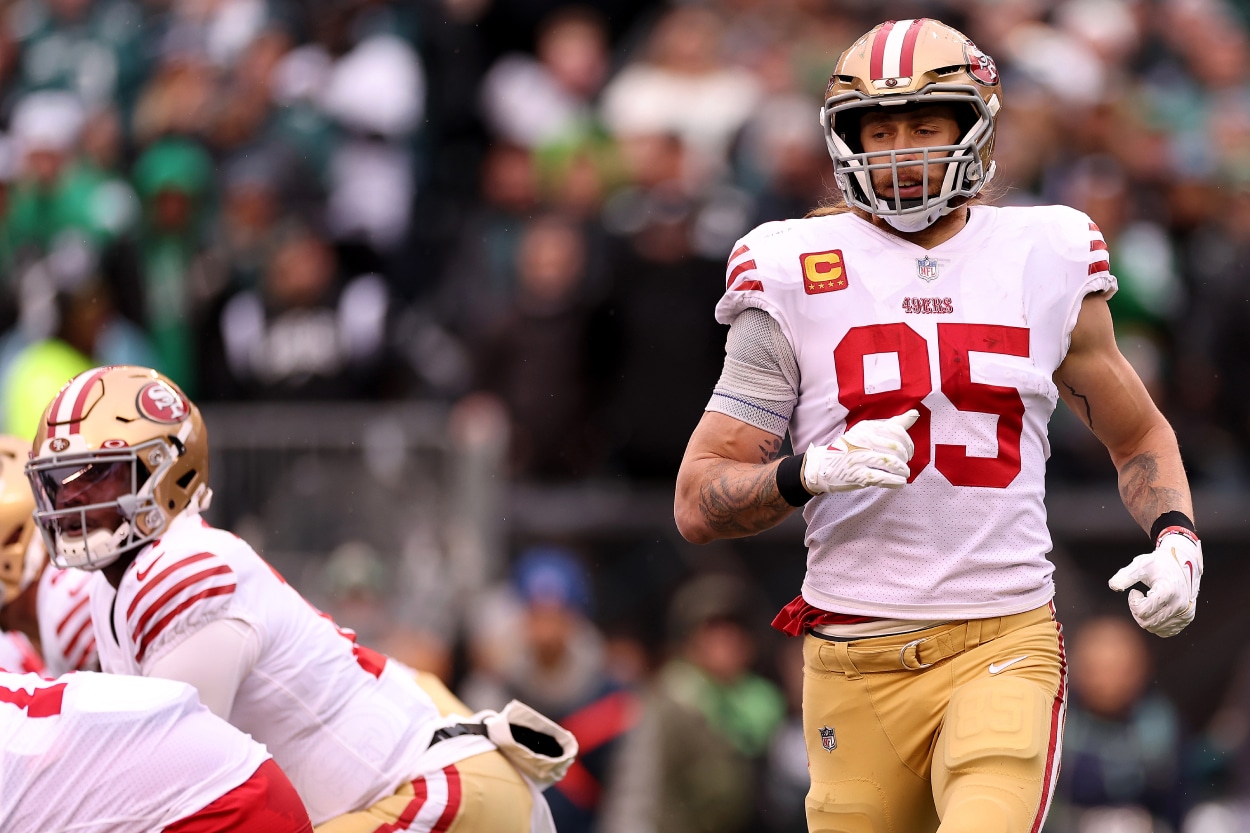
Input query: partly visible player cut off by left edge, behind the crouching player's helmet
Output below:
<box><xmin>0</xmin><ymin>435</ymin><xmax>100</xmax><ymax>677</ymax></box>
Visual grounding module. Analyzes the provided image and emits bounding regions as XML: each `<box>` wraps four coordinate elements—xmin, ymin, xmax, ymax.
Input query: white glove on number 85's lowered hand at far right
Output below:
<box><xmin>1108</xmin><ymin>533</ymin><xmax>1203</xmax><ymax>637</ymax></box>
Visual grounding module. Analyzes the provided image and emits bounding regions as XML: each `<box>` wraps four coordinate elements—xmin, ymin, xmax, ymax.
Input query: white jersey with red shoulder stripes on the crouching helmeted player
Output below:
<box><xmin>91</xmin><ymin>512</ymin><xmax>439</xmax><ymax>824</ymax></box>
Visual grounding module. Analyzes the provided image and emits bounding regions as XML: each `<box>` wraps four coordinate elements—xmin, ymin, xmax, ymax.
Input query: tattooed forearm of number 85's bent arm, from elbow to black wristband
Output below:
<box><xmin>699</xmin><ymin>457</ymin><xmax>794</xmax><ymax>537</ymax></box>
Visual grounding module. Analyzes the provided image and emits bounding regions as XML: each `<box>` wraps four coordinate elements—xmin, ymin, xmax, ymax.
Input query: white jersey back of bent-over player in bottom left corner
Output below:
<box><xmin>0</xmin><ymin>672</ymin><xmax>269</xmax><ymax>833</ymax></box>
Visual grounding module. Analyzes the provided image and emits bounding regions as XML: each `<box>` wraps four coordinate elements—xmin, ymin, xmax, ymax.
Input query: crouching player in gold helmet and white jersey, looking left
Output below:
<box><xmin>26</xmin><ymin>366</ymin><xmax>571</xmax><ymax>833</ymax></box>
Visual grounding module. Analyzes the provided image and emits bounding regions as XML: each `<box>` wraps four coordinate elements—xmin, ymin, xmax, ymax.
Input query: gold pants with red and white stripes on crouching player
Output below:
<box><xmin>314</xmin><ymin>672</ymin><xmax>533</xmax><ymax>833</ymax></box>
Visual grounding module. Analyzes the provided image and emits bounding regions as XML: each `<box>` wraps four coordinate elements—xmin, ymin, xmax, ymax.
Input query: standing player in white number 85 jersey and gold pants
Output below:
<box><xmin>674</xmin><ymin>19</ymin><xmax>1203</xmax><ymax>833</ymax></box>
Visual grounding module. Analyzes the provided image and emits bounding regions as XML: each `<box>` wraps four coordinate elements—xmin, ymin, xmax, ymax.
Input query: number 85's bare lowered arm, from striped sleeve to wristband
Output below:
<box><xmin>1055</xmin><ymin>295</ymin><xmax>1194</xmax><ymax>530</ymax></box>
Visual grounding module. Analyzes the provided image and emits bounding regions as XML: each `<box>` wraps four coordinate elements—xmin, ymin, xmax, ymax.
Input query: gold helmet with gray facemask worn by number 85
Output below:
<box><xmin>820</xmin><ymin>18</ymin><xmax>1003</xmax><ymax>231</ymax></box>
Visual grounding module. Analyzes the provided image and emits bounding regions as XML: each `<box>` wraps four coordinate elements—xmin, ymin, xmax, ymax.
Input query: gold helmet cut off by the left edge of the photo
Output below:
<box><xmin>0</xmin><ymin>435</ymin><xmax>44</xmax><ymax>608</ymax></box>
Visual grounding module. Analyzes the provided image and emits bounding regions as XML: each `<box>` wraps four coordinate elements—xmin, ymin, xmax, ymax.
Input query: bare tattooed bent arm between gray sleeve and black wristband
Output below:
<box><xmin>673</xmin><ymin>410</ymin><xmax>794</xmax><ymax>544</ymax></box>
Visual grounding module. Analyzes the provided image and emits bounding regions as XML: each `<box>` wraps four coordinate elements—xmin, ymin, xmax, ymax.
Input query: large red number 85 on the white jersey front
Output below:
<box><xmin>834</xmin><ymin>318</ymin><xmax>1029</xmax><ymax>489</ymax></box>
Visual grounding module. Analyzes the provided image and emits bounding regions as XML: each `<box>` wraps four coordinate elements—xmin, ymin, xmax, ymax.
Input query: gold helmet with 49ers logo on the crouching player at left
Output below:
<box><xmin>26</xmin><ymin>365</ymin><xmax>211</xmax><ymax>569</ymax></box>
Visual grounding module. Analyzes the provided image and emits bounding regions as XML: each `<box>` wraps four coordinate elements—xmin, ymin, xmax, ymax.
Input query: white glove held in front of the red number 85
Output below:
<box><xmin>803</xmin><ymin>409</ymin><xmax>920</xmax><ymax>494</ymax></box>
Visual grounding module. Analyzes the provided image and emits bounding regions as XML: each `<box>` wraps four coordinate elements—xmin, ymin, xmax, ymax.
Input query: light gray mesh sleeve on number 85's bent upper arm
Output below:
<box><xmin>708</xmin><ymin>308</ymin><xmax>799</xmax><ymax>437</ymax></box>
